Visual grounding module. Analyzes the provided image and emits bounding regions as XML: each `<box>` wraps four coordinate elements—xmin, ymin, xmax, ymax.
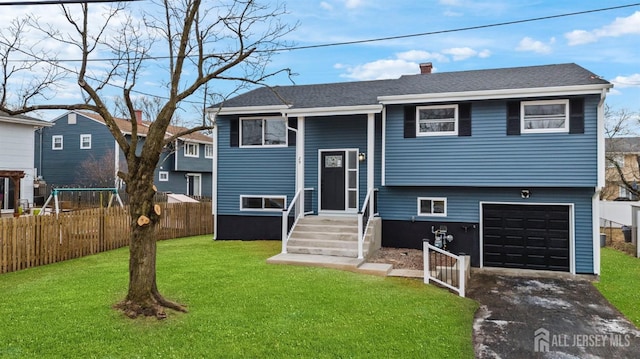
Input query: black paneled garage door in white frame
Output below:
<box><xmin>482</xmin><ymin>204</ymin><xmax>570</xmax><ymax>272</ymax></box>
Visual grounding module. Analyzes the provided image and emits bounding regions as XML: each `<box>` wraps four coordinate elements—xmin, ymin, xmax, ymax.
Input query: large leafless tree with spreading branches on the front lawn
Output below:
<box><xmin>0</xmin><ymin>0</ymin><xmax>292</xmax><ymax>318</ymax></box>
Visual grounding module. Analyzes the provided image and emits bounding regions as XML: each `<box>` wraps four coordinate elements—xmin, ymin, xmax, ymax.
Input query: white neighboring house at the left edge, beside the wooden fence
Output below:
<box><xmin>0</xmin><ymin>111</ymin><xmax>53</xmax><ymax>213</ymax></box>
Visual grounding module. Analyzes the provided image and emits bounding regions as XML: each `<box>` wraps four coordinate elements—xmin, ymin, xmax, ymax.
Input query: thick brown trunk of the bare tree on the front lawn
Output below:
<box><xmin>115</xmin><ymin>173</ymin><xmax>187</xmax><ymax>319</ymax></box>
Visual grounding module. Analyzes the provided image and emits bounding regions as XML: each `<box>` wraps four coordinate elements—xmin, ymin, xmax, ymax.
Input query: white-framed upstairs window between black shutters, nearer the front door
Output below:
<box><xmin>416</xmin><ymin>105</ymin><xmax>458</xmax><ymax>136</ymax></box>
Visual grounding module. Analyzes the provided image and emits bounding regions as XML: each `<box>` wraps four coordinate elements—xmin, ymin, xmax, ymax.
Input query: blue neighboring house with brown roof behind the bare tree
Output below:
<box><xmin>35</xmin><ymin>111</ymin><xmax>213</xmax><ymax>197</ymax></box>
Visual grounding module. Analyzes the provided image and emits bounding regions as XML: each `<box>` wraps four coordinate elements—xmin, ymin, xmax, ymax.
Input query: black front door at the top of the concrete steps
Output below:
<box><xmin>320</xmin><ymin>151</ymin><xmax>346</xmax><ymax>211</ymax></box>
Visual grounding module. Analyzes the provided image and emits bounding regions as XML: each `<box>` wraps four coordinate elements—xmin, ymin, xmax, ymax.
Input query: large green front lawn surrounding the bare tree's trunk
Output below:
<box><xmin>0</xmin><ymin>236</ymin><xmax>477</xmax><ymax>358</ymax></box>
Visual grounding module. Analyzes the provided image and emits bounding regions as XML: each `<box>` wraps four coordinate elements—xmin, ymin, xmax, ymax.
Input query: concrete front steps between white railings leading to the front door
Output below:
<box><xmin>287</xmin><ymin>216</ymin><xmax>377</xmax><ymax>258</ymax></box>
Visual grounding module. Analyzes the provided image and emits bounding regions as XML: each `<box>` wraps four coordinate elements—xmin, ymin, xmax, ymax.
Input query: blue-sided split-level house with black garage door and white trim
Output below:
<box><xmin>210</xmin><ymin>64</ymin><xmax>612</xmax><ymax>274</ymax></box>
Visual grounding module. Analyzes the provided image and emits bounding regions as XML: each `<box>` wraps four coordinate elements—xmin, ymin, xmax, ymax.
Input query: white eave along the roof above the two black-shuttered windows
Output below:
<box><xmin>378</xmin><ymin>84</ymin><xmax>613</xmax><ymax>105</ymax></box>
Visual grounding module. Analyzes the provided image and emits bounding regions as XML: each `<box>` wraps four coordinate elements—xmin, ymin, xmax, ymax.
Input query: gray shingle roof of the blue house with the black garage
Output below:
<box><xmin>219</xmin><ymin>63</ymin><xmax>609</xmax><ymax>108</ymax></box>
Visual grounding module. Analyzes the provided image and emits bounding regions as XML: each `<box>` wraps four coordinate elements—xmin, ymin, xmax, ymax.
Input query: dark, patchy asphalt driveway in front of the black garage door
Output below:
<box><xmin>467</xmin><ymin>273</ymin><xmax>640</xmax><ymax>358</ymax></box>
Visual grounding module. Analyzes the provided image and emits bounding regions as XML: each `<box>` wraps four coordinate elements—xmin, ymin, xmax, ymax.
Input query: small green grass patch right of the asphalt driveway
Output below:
<box><xmin>594</xmin><ymin>248</ymin><xmax>640</xmax><ymax>327</ymax></box>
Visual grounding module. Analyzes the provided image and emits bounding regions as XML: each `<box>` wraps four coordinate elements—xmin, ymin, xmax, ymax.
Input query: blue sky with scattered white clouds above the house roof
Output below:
<box><xmin>0</xmin><ymin>0</ymin><xmax>640</xmax><ymax>120</ymax></box>
